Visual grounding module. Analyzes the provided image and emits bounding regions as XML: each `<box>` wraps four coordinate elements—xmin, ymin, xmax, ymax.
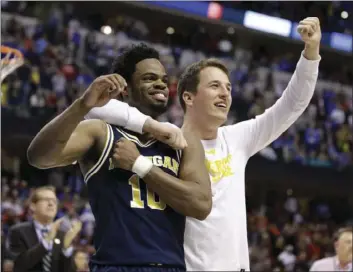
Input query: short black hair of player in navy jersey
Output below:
<box><xmin>111</xmin><ymin>43</ymin><xmax>159</xmax><ymax>83</ymax></box>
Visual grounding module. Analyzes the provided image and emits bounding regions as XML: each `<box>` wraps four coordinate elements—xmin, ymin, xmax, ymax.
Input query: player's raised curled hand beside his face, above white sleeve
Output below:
<box><xmin>80</xmin><ymin>74</ymin><xmax>127</xmax><ymax>109</ymax></box>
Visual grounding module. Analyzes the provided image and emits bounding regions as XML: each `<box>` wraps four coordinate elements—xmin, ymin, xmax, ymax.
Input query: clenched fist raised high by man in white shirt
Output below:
<box><xmin>297</xmin><ymin>17</ymin><xmax>321</xmax><ymax>60</ymax></box>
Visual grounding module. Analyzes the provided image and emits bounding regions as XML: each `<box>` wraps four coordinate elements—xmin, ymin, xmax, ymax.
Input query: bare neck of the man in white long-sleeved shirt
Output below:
<box><xmin>183</xmin><ymin>114</ymin><xmax>218</xmax><ymax>140</ymax></box>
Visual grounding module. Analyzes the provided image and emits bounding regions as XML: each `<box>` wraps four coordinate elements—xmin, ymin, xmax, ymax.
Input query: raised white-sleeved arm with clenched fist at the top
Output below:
<box><xmin>231</xmin><ymin>17</ymin><xmax>321</xmax><ymax>157</ymax></box>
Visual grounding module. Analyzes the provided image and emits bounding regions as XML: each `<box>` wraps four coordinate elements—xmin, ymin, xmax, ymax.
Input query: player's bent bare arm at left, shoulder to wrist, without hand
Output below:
<box><xmin>27</xmin><ymin>99</ymin><xmax>106</xmax><ymax>169</ymax></box>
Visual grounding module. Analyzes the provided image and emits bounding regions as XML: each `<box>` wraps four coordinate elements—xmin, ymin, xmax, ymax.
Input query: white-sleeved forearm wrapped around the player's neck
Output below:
<box><xmin>85</xmin><ymin>99</ymin><xmax>150</xmax><ymax>134</ymax></box>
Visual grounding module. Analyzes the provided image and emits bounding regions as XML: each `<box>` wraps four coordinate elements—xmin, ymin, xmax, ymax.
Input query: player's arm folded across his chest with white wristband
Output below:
<box><xmin>113</xmin><ymin>132</ymin><xmax>212</xmax><ymax>220</ymax></box>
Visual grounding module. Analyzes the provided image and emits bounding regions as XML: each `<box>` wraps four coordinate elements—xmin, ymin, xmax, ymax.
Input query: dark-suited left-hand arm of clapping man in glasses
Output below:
<box><xmin>9</xmin><ymin>226</ymin><xmax>47</xmax><ymax>271</ymax></box>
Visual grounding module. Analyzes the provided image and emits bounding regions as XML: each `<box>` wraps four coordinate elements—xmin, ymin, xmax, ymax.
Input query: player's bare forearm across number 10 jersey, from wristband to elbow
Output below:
<box><xmin>143</xmin><ymin>166</ymin><xmax>210</xmax><ymax>220</ymax></box>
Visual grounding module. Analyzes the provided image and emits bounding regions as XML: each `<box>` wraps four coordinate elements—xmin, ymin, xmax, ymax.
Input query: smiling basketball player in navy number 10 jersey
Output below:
<box><xmin>28</xmin><ymin>45</ymin><xmax>212</xmax><ymax>272</ymax></box>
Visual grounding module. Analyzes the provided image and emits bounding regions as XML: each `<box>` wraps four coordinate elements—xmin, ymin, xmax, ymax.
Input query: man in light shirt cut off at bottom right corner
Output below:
<box><xmin>310</xmin><ymin>227</ymin><xmax>353</xmax><ymax>271</ymax></box>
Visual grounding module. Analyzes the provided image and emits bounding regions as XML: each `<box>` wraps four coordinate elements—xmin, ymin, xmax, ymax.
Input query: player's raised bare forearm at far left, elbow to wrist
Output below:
<box><xmin>27</xmin><ymin>100</ymin><xmax>89</xmax><ymax>167</ymax></box>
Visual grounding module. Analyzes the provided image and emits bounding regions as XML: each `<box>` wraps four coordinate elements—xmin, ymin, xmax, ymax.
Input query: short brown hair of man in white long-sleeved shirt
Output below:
<box><xmin>177</xmin><ymin>58</ymin><xmax>229</xmax><ymax>111</ymax></box>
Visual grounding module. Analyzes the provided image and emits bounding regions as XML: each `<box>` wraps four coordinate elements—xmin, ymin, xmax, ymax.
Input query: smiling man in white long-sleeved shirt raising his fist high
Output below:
<box><xmin>84</xmin><ymin>17</ymin><xmax>321</xmax><ymax>271</ymax></box>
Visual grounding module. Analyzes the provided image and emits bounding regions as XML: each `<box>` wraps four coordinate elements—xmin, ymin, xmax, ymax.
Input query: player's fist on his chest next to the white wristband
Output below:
<box><xmin>113</xmin><ymin>138</ymin><xmax>140</xmax><ymax>171</ymax></box>
